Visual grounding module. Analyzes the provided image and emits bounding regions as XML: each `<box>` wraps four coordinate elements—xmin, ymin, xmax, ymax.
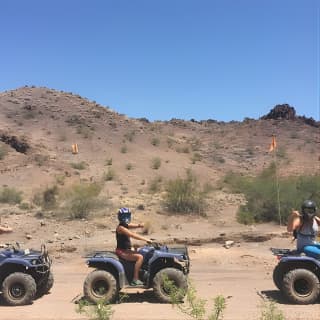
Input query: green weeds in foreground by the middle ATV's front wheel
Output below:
<box><xmin>164</xmin><ymin>277</ymin><xmax>226</xmax><ymax>320</ymax></box>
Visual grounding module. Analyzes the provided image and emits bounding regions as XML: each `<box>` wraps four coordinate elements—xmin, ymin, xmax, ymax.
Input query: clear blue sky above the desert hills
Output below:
<box><xmin>0</xmin><ymin>0</ymin><xmax>320</xmax><ymax>121</ymax></box>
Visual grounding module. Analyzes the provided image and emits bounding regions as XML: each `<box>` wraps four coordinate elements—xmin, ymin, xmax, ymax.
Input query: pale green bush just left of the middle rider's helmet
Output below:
<box><xmin>63</xmin><ymin>183</ymin><xmax>102</xmax><ymax>219</ymax></box>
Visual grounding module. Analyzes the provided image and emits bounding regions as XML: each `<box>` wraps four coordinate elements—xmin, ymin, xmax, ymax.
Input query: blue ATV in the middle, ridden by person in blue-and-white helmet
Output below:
<box><xmin>83</xmin><ymin>243</ymin><xmax>190</xmax><ymax>303</ymax></box>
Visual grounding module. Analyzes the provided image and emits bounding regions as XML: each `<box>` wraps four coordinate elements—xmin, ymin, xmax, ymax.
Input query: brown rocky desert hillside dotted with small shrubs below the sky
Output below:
<box><xmin>0</xmin><ymin>87</ymin><xmax>320</xmax><ymax>216</ymax></box>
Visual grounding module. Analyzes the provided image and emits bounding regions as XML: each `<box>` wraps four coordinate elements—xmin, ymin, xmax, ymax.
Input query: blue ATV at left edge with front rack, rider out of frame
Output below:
<box><xmin>0</xmin><ymin>244</ymin><xmax>54</xmax><ymax>306</ymax></box>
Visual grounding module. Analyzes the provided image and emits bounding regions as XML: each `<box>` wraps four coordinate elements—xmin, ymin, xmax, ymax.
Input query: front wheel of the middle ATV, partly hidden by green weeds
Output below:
<box><xmin>153</xmin><ymin>268</ymin><xmax>188</xmax><ymax>303</ymax></box>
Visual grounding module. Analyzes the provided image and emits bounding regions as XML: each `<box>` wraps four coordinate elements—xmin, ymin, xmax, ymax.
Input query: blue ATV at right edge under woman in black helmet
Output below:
<box><xmin>271</xmin><ymin>248</ymin><xmax>320</xmax><ymax>304</ymax></box>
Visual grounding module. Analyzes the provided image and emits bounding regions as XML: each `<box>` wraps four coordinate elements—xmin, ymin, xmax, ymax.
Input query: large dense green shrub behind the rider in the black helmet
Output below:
<box><xmin>224</xmin><ymin>163</ymin><xmax>320</xmax><ymax>224</ymax></box>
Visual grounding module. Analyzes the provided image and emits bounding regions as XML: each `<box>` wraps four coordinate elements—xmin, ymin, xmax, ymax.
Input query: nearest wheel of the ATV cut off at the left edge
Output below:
<box><xmin>2</xmin><ymin>272</ymin><xmax>37</xmax><ymax>306</ymax></box>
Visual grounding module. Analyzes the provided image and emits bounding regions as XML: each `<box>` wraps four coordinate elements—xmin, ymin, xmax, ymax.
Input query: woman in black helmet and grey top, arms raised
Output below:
<box><xmin>287</xmin><ymin>200</ymin><xmax>320</xmax><ymax>259</ymax></box>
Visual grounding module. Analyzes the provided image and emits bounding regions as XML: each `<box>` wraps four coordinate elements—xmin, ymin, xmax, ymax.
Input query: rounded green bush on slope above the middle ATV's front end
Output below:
<box><xmin>163</xmin><ymin>170</ymin><xmax>208</xmax><ymax>214</ymax></box>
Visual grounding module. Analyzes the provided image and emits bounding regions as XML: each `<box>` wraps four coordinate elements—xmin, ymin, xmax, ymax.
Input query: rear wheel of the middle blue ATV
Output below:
<box><xmin>83</xmin><ymin>270</ymin><xmax>119</xmax><ymax>303</ymax></box>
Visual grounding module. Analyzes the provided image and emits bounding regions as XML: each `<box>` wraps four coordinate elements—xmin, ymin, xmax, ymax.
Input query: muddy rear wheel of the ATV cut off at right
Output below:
<box><xmin>282</xmin><ymin>269</ymin><xmax>320</xmax><ymax>304</ymax></box>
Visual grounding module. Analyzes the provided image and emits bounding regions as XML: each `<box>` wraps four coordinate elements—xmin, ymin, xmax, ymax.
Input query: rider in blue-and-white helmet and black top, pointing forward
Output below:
<box><xmin>116</xmin><ymin>208</ymin><xmax>151</xmax><ymax>286</ymax></box>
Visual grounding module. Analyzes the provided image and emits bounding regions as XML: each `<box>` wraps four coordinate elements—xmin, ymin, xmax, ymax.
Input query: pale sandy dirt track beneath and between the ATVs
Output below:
<box><xmin>0</xmin><ymin>239</ymin><xmax>320</xmax><ymax>320</ymax></box>
